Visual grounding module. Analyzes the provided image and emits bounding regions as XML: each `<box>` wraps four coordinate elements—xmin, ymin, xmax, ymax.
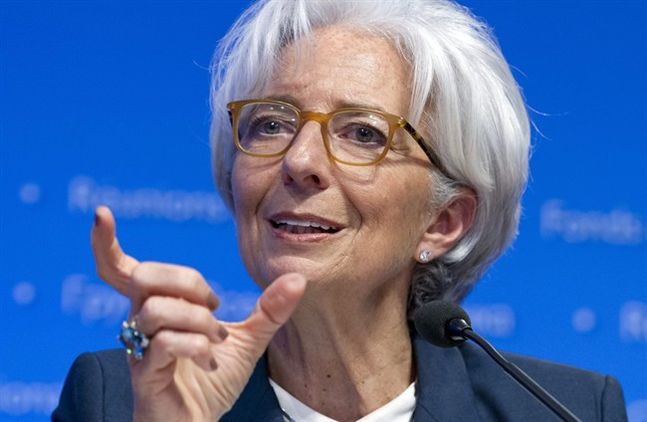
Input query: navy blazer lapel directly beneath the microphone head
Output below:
<box><xmin>412</xmin><ymin>334</ymin><xmax>480</xmax><ymax>422</ymax></box>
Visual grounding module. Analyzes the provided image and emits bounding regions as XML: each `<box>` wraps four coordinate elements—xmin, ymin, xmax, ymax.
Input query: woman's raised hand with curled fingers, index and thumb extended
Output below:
<box><xmin>92</xmin><ymin>207</ymin><xmax>306</xmax><ymax>421</ymax></box>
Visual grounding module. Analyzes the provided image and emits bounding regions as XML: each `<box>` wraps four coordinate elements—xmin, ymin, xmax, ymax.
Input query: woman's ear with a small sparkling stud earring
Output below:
<box><xmin>415</xmin><ymin>188</ymin><xmax>478</xmax><ymax>264</ymax></box>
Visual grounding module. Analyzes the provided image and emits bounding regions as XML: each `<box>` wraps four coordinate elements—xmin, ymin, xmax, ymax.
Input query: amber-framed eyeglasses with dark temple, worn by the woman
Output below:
<box><xmin>227</xmin><ymin>100</ymin><xmax>453</xmax><ymax>179</ymax></box>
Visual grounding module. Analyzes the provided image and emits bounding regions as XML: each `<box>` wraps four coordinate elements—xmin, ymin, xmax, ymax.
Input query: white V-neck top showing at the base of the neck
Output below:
<box><xmin>270</xmin><ymin>378</ymin><xmax>416</xmax><ymax>422</ymax></box>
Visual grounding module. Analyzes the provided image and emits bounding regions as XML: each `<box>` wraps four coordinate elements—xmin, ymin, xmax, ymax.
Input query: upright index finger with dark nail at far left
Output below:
<box><xmin>91</xmin><ymin>206</ymin><xmax>139</xmax><ymax>296</ymax></box>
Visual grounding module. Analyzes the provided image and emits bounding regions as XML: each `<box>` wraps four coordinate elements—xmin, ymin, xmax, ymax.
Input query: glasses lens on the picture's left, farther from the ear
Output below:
<box><xmin>238</xmin><ymin>102</ymin><xmax>299</xmax><ymax>155</ymax></box>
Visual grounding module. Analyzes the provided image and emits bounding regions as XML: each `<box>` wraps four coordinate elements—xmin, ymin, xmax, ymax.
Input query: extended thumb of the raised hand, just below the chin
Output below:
<box><xmin>243</xmin><ymin>273</ymin><xmax>307</xmax><ymax>354</ymax></box>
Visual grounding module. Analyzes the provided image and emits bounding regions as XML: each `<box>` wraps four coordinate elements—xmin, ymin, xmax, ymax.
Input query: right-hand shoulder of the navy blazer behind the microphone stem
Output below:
<box><xmin>460</xmin><ymin>344</ymin><xmax>626</xmax><ymax>421</ymax></box>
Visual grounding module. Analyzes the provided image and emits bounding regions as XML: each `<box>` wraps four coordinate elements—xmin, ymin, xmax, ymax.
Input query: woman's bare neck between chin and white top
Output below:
<box><xmin>268</xmin><ymin>282</ymin><xmax>414</xmax><ymax>421</ymax></box>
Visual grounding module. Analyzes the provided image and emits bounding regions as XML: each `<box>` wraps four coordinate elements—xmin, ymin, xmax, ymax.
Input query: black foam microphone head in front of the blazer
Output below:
<box><xmin>413</xmin><ymin>300</ymin><xmax>472</xmax><ymax>347</ymax></box>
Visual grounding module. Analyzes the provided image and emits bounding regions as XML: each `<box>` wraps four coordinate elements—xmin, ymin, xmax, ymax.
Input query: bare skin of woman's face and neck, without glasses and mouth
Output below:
<box><xmin>232</xmin><ymin>28</ymin><xmax>470</xmax><ymax>420</ymax></box>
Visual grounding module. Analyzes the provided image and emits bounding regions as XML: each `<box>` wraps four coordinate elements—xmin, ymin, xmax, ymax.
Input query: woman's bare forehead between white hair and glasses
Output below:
<box><xmin>265</xmin><ymin>27</ymin><xmax>410</xmax><ymax>114</ymax></box>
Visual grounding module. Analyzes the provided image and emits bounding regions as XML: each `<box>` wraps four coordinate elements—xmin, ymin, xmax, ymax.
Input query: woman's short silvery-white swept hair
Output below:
<box><xmin>211</xmin><ymin>0</ymin><xmax>530</xmax><ymax>315</ymax></box>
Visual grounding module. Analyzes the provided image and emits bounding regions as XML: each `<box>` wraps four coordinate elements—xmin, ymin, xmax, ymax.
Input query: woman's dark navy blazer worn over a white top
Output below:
<box><xmin>52</xmin><ymin>338</ymin><xmax>627</xmax><ymax>422</ymax></box>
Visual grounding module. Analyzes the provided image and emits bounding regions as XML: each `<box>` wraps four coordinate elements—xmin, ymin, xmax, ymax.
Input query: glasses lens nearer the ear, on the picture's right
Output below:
<box><xmin>328</xmin><ymin>111</ymin><xmax>390</xmax><ymax>164</ymax></box>
